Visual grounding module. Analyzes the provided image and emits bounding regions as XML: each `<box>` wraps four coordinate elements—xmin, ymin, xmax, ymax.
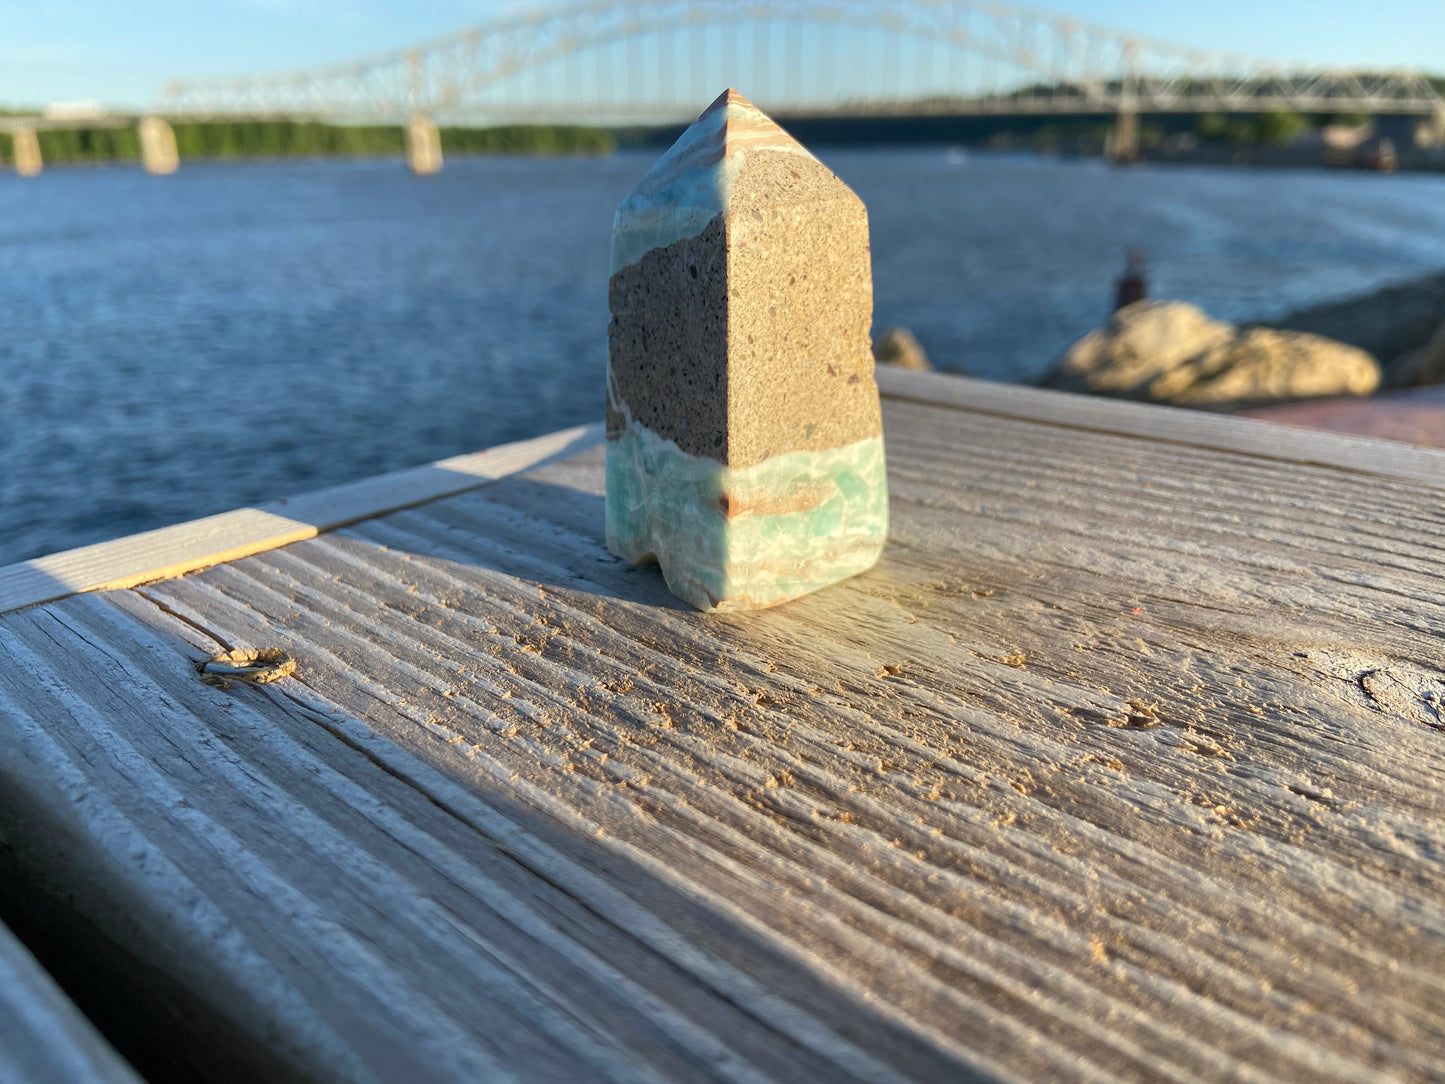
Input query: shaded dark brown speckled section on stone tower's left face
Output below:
<box><xmin>607</xmin><ymin>214</ymin><xmax>728</xmax><ymax>463</ymax></box>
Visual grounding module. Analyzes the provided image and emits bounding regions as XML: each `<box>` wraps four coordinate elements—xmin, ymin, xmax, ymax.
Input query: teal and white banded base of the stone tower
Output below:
<box><xmin>607</xmin><ymin>422</ymin><xmax>889</xmax><ymax>610</ymax></box>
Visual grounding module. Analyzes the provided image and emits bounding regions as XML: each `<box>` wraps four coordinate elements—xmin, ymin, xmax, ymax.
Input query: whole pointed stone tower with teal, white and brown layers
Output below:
<box><xmin>607</xmin><ymin>91</ymin><xmax>889</xmax><ymax>610</ymax></box>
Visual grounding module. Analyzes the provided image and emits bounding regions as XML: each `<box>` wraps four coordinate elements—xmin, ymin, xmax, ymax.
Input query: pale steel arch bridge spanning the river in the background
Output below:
<box><xmin>155</xmin><ymin>0</ymin><xmax>1445</xmax><ymax>123</ymax></box>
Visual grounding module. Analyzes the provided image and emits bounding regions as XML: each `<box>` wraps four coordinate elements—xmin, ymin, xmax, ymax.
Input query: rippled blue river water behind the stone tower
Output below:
<box><xmin>0</xmin><ymin>149</ymin><xmax>1445</xmax><ymax>565</ymax></box>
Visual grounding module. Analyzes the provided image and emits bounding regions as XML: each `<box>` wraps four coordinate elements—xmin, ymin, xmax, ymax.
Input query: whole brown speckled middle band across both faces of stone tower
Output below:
<box><xmin>607</xmin><ymin>145</ymin><xmax>883</xmax><ymax>467</ymax></box>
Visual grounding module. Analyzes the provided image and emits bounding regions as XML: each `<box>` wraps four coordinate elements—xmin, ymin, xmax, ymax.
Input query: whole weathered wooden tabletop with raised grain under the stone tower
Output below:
<box><xmin>0</xmin><ymin>384</ymin><xmax>1445</xmax><ymax>1081</ymax></box>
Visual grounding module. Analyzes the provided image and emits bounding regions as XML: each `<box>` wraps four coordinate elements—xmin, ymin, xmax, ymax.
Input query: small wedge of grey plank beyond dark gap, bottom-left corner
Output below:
<box><xmin>0</xmin><ymin>925</ymin><xmax>140</xmax><ymax>1084</ymax></box>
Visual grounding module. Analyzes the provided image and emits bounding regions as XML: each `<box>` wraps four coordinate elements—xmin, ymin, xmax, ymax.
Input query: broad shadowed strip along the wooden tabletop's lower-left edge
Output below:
<box><xmin>0</xmin><ymin>595</ymin><xmax>971</xmax><ymax>1081</ymax></box>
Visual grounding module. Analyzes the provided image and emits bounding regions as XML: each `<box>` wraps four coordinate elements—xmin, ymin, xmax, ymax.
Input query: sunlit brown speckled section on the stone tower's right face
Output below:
<box><xmin>727</xmin><ymin>150</ymin><xmax>883</xmax><ymax>467</ymax></box>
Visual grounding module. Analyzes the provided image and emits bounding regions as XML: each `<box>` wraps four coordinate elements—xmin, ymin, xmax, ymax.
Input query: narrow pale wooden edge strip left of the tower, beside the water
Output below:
<box><xmin>0</xmin><ymin>425</ymin><xmax>601</xmax><ymax>613</ymax></box>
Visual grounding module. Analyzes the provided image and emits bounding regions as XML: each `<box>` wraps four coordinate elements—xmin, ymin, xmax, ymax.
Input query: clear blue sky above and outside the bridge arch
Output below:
<box><xmin>0</xmin><ymin>0</ymin><xmax>1445</xmax><ymax>107</ymax></box>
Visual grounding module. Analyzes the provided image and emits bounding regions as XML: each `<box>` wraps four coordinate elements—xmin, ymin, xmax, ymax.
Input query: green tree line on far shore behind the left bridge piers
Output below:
<box><xmin>0</xmin><ymin>120</ymin><xmax>617</xmax><ymax>163</ymax></box>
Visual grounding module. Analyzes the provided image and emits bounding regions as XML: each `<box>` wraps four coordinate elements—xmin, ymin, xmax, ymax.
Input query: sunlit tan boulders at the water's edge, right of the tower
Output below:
<box><xmin>1043</xmin><ymin>301</ymin><xmax>1380</xmax><ymax>409</ymax></box>
